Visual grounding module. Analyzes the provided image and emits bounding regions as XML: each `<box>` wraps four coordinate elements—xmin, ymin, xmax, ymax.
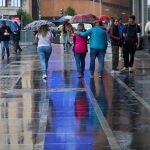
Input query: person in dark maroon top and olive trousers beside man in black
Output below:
<box><xmin>110</xmin><ymin>19</ymin><xmax>121</xmax><ymax>73</ymax></box>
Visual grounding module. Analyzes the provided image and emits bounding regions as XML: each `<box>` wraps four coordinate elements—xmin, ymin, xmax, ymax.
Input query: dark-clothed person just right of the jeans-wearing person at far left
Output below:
<box><xmin>12</xmin><ymin>22</ymin><xmax>22</xmax><ymax>54</ymax></box>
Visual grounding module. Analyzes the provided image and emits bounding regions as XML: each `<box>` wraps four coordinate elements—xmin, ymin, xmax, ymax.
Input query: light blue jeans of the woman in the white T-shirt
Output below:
<box><xmin>37</xmin><ymin>46</ymin><xmax>52</xmax><ymax>74</ymax></box>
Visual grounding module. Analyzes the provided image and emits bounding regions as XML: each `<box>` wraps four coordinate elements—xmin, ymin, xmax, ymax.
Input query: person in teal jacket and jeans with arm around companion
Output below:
<box><xmin>77</xmin><ymin>20</ymin><xmax>107</xmax><ymax>78</ymax></box>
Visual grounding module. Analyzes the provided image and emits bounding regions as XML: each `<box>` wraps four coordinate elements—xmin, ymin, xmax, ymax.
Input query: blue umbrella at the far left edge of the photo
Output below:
<box><xmin>0</xmin><ymin>19</ymin><xmax>18</xmax><ymax>31</ymax></box>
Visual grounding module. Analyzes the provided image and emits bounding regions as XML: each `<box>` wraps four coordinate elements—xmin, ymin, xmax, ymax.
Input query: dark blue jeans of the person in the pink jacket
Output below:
<box><xmin>74</xmin><ymin>53</ymin><xmax>86</xmax><ymax>74</ymax></box>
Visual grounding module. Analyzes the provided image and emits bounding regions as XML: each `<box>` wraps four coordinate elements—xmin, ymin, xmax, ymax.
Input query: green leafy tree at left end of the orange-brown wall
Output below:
<box><xmin>17</xmin><ymin>9</ymin><xmax>33</xmax><ymax>27</ymax></box>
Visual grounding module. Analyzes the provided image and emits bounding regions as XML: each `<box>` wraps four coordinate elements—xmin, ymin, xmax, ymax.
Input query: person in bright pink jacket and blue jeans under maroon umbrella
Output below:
<box><xmin>73</xmin><ymin>23</ymin><xmax>87</xmax><ymax>78</ymax></box>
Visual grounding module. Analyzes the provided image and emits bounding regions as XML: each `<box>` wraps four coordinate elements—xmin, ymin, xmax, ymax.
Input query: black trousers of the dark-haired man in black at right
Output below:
<box><xmin>123</xmin><ymin>41</ymin><xmax>136</xmax><ymax>68</ymax></box>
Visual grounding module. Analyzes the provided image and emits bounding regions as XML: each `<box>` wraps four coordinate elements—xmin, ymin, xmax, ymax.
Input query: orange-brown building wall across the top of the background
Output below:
<box><xmin>41</xmin><ymin>0</ymin><xmax>131</xmax><ymax>21</ymax></box>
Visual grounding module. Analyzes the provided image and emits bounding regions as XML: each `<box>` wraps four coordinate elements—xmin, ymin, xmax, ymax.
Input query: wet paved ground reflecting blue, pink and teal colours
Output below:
<box><xmin>0</xmin><ymin>45</ymin><xmax>150</xmax><ymax>150</ymax></box>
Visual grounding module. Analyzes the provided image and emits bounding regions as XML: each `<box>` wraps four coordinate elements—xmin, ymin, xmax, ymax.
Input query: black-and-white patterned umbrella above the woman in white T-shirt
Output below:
<box><xmin>24</xmin><ymin>20</ymin><xmax>55</xmax><ymax>31</ymax></box>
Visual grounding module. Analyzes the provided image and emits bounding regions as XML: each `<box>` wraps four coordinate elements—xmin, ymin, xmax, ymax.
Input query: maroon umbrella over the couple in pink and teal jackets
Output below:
<box><xmin>69</xmin><ymin>14</ymin><xmax>98</xmax><ymax>23</ymax></box>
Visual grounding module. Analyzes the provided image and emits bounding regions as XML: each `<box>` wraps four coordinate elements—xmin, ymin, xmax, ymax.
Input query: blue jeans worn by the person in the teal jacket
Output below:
<box><xmin>90</xmin><ymin>48</ymin><xmax>105</xmax><ymax>75</ymax></box>
